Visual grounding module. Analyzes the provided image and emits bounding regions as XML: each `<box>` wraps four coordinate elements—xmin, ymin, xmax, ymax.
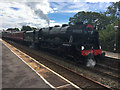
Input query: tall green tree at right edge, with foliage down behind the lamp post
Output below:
<box><xmin>99</xmin><ymin>1</ymin><xmax>120</xmax><ymax>52</ymax></box>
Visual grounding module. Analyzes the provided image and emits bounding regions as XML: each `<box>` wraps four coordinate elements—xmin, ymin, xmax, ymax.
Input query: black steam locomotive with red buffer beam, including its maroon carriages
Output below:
<box><xmin>2</xmin><ymin>22</ymin><xmax>104</xmax><ymax>67</ymax></box>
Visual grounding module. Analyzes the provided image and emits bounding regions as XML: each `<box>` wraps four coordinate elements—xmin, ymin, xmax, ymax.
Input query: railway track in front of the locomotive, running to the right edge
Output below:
<box><xmin>58</xmin><ymin>55</ymin><xmax>120</xmax><ymax>82</ymax></box>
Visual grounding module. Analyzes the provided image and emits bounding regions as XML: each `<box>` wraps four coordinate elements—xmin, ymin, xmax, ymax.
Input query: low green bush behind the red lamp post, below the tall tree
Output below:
<box><xmin>99</xmin><ymin>24</ymin><xmax>120</xmax><ymax>52</ymax></box>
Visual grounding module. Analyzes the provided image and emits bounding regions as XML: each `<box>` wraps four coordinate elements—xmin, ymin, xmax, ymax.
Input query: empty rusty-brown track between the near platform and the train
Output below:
<box><xmin>2</xmin><ymin>39</ymin><xmax>110</xmax><ymax>89</ymax></box>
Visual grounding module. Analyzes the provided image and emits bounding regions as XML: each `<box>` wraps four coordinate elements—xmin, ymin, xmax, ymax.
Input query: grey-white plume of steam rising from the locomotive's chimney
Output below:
<box><xmin>26</xmin><ymin>2</ymin><xmax>50</xmax><ymax>25</ymax></box>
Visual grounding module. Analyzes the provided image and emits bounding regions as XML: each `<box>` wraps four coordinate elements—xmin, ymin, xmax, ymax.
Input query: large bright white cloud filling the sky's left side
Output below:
<box><xmin>0</xmin><ymin>0</ymin><xmax>52</xmax><ymax>29</ymax></box>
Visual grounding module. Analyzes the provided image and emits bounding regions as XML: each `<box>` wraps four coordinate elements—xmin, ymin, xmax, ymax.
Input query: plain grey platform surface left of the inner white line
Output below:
<box><xmin>2</xmin><ymin>44</ymin><xmax>50</xmax><ymax>88</ymax></box>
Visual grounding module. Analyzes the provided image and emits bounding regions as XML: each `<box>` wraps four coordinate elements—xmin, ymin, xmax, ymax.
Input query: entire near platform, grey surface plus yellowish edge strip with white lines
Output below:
<box><xmin>0</xmin><ymin>40</ymin><xmax>80</xmax><ymax>90</ymax></box>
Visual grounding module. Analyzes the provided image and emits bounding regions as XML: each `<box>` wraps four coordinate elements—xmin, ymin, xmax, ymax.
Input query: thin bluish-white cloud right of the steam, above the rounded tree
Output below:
<box><xmin>50</xmin><ymin>2</ymin><xmax>110</xmax><ymax>13</ymax></box>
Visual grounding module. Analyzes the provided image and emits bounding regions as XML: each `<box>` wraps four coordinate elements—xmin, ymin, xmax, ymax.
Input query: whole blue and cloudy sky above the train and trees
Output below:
<box><xmin>0</xmin><ymin>0</ymin><xmax>119</xmax><ymax>30</ymax></box>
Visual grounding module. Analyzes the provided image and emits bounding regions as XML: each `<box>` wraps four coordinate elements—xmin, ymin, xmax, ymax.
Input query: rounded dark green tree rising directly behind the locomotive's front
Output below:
<box><xmin>69</xmin><ymin>11</ymin><xmax>110</xmax><ymax>29</ymax></box>
